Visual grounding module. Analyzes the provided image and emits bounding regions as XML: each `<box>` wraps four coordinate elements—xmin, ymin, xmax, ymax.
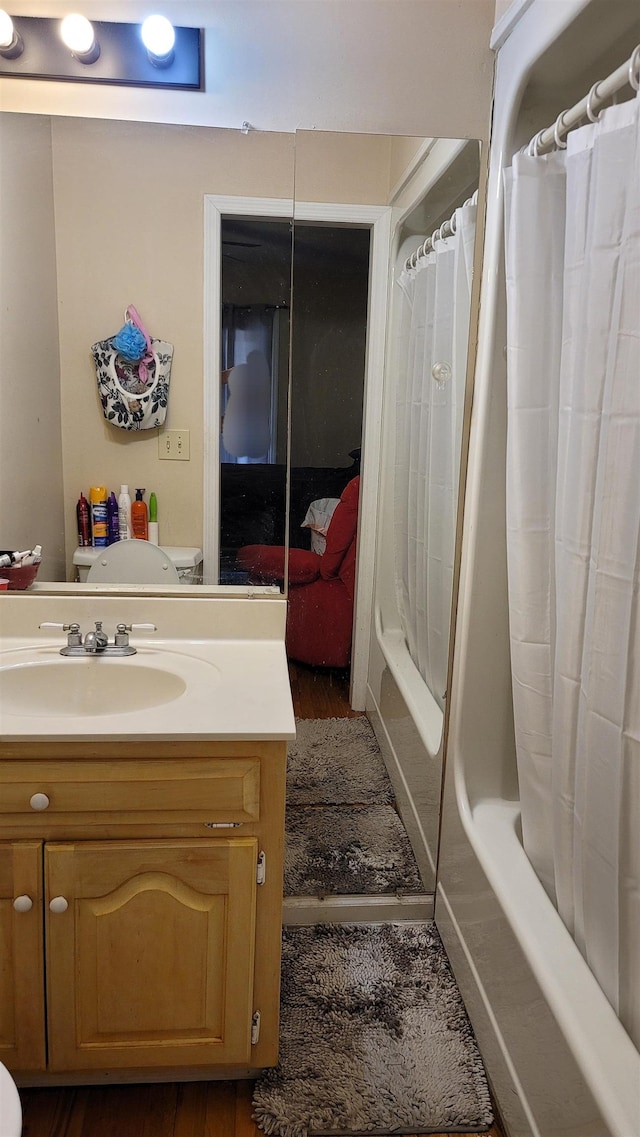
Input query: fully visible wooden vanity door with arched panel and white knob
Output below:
<box><xmin>44</xmin><ymin>837</ymin><xmax>258</xmax><ymax>1071</ymax></box>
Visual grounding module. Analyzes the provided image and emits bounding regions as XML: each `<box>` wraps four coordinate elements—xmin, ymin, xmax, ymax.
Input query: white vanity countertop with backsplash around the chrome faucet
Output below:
<box><xmin>0</xmin><ymin>598</ymin><xmax>296</xmax><ymax>741</ymax></box>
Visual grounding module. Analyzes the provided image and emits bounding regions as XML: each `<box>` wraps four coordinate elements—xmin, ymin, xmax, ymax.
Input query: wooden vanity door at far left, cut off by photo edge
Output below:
<box><xmin>0</xmin><ymin>841</ymin><xmax>47</xmax><ymax>1073</ymax></box>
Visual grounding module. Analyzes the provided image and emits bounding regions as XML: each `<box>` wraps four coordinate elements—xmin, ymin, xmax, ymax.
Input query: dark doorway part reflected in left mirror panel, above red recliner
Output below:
<box><xmin>219</xmin><ymin>217</ymin><xmax>292</xmax><ymax>584</ymax></box>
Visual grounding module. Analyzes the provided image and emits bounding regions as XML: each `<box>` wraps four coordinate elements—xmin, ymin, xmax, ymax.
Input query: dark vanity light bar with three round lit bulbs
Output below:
<box><xmin>0</xmin><ymin>9</ymin><xmax>205</xmax><ymax>91</ymax></box>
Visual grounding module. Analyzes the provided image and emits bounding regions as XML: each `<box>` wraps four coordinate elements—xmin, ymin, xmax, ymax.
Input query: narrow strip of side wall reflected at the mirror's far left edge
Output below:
<box><xmin>0</xmin><ymin>115</ymin><xmax>64</xmax><ymax>580</ymax></box>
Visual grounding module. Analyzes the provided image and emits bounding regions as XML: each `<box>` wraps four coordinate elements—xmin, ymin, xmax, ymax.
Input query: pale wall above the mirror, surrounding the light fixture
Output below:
<box><xmin>0</xmin><ymin>0</ymin><xmax>494</xmax><ymax>138</ymax></box>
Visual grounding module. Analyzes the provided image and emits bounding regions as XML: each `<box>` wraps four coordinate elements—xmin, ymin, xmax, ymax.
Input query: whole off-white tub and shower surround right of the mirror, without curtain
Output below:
<box><xmin>435</xmin><ymin>0</ymin><xmax>640</xmax><ymax>1137</ymax></box>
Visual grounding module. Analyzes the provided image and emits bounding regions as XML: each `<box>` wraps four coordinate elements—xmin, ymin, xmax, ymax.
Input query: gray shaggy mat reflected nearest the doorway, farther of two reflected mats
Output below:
<box><xmin>286</xmin><ymin>719</ymin><xmax>393</xmax><ymax>805</ymax></box>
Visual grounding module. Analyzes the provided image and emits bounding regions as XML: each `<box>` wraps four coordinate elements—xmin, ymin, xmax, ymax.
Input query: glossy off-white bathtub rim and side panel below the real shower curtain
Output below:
<box><xmin>435</xmin><ymin>786</ymin><xmax>640</xmax><ymax>1137</ymax></box>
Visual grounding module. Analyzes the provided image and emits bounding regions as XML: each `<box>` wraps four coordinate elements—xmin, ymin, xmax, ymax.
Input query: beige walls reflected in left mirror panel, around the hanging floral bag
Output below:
<box><xmin>0</xmin><ymin>113</ymin><xmax>294</xmax><ymax>590</ymax></box>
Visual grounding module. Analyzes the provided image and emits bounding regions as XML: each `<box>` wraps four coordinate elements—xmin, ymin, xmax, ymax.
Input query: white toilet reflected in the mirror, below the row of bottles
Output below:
<box><xmin>73</xmin><ymin>540</ymin><xmax>202</xmax><ymax>584</ymax></box>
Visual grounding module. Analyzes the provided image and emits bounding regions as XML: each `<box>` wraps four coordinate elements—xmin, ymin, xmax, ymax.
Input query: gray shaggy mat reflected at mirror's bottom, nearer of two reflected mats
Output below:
<box><xmin>284</xmin><ymin>805</ymin><xmax>424</xmax><ymax>896</ymax></box>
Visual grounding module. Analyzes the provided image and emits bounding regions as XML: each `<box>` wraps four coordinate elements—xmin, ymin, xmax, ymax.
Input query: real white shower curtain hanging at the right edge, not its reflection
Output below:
<box><xmin>505</xmin><ymin>88</ymin><xmax>640</xmax><ymax>1045</ymax></box>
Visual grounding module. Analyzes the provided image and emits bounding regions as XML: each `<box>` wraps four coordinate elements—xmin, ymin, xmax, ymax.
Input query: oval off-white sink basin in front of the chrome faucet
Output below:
<box><xmin>0</xmin><ymin>657</ymin><xmax>186</xmax><ymax>717</ymax></box>
